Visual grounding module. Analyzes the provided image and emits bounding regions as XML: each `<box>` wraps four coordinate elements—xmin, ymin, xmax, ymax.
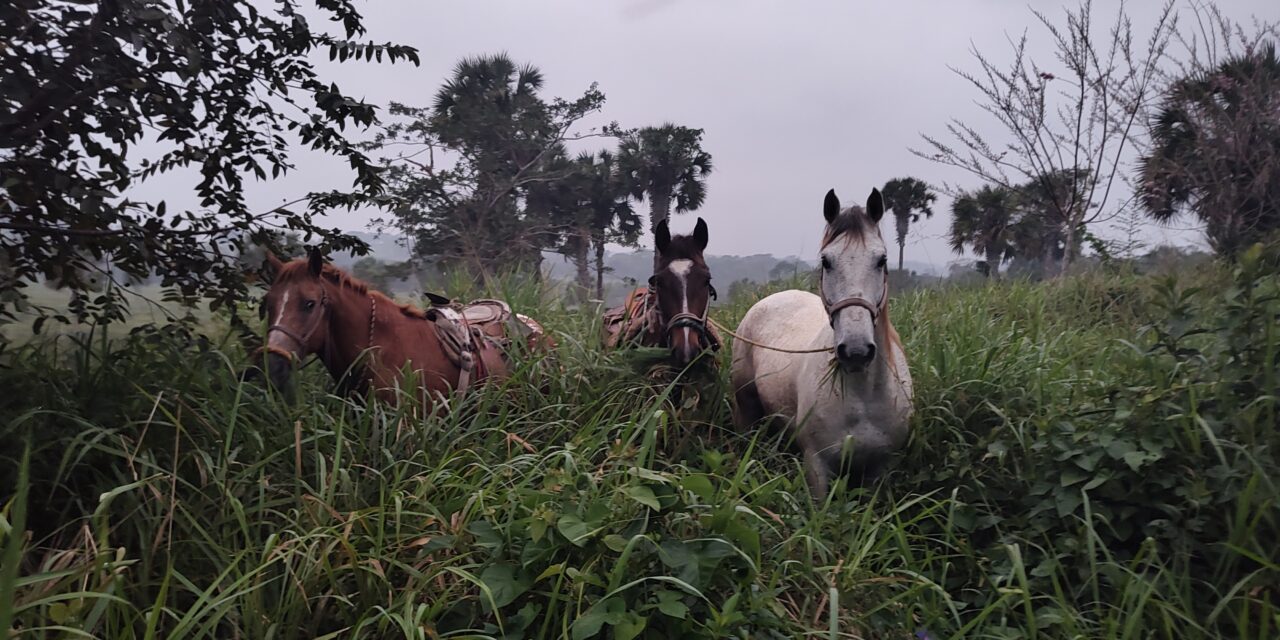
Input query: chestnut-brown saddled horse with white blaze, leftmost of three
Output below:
<box><xmin>262</xmin><ymin>250</ymin><xmax>550</xmax><ymax>408</ymax></box>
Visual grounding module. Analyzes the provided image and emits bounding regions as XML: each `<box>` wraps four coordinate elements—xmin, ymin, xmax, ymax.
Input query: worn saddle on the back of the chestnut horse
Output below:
<box><xmin>426</xmin><ymin>293</ymin><xmax>550</xmax><ymax>392</ymax></box>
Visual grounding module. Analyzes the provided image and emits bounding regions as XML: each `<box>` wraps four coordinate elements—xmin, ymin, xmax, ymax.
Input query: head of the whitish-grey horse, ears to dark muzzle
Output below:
<box><xmin>819</xmin><ymin>189</ymin><xmax>888</xmax><ymax>372</ymax></box>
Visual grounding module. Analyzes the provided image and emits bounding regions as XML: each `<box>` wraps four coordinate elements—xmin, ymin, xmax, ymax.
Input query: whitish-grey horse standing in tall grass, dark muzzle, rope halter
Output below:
<box><xmin>732</xmin><ymin>189</ymin><xmax>911</xmax><ymax>500</ymax></box>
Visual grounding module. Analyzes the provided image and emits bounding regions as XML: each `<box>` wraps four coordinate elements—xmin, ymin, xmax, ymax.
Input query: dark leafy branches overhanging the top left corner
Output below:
<box><xmin>0</xmin><ymin>0</ymin><xmax>417</xmax><ymax>330</ymax></box>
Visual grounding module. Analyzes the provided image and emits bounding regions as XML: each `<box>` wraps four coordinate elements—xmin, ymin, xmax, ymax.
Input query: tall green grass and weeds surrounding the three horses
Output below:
<box><xmin>0</xmin><ymin>245</ymin><xmax>1280</xmax><ymax>639</ymax></box>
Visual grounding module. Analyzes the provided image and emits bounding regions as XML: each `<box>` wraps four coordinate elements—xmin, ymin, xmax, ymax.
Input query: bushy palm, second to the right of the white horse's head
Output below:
<box><xmin>951</xmin><ymin>184</ymin><xmax>1018</xmax><ymax>279</ymax></box>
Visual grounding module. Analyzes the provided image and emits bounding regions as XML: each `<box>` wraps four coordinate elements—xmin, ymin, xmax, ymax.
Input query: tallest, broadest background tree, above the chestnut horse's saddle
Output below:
<box><xmin>366</xmin><ymin>54</ymin><xmax>607</xmax><ymax>285</ymax></box>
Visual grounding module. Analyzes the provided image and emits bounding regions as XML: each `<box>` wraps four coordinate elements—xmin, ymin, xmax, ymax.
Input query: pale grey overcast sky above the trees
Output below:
<box><xmin>209</xmin><ymin>0</ymin><xmax>1280</xmax><ymax>268</ymax></box>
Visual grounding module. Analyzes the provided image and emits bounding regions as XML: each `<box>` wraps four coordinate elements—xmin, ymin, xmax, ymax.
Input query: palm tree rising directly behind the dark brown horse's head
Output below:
<box><xmin>618</xmin><ymin>123</ymin><xmax>712</xmax><ymax>266</ymax></box>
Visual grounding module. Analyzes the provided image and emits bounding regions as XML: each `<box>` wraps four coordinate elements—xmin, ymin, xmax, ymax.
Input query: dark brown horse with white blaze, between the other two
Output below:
<box><xmin>604</xmin><ymin>218</ymin><xmax>721</xmax><ymax>367</ymax></box>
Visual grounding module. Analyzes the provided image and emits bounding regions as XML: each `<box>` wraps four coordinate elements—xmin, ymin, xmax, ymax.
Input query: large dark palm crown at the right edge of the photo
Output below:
<box><xmin>1138</xmin><ymin>44</ymin><xmax>1280</xmax><ymax>256</ymax></box>
